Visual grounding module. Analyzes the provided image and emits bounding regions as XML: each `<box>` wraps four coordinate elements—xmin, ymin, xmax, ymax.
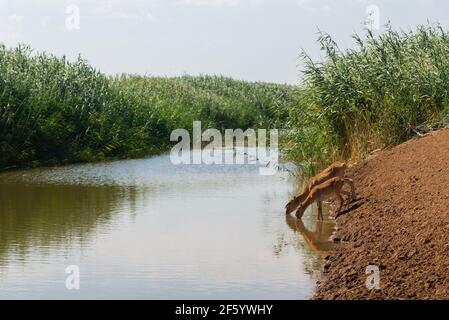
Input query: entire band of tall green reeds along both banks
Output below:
<box><xmin>6</xmin><ymin>25</ymin><xmax>449</xmax><ymax>174</ymax></box>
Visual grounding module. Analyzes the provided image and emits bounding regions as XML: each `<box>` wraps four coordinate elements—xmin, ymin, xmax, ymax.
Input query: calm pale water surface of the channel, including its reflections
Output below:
<box><xmin>0</xmin><ymin>151</ymin><xmax>332</xmax><ymax>299</ymax></box>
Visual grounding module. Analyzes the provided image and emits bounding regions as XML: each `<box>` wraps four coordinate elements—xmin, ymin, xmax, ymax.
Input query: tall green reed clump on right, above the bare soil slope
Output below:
<box><xmin>287</xmin><ymin>25</ymin><xmax>449</xmax><ymax>174</ymax></box>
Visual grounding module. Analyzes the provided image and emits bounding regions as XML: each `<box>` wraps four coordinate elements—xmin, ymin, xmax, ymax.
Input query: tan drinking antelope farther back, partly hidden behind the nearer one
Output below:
<box><xmin>285</xmin><ymin>162</ymin><xmax>348</xmax><ymax>214</ymax></box>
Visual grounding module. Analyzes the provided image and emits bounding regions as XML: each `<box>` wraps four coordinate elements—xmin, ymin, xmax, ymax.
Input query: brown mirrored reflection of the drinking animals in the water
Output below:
<box><xmin>286</xmin><ymin>215</ymin><xmax>334</xmax><ymax>257</ymax></box>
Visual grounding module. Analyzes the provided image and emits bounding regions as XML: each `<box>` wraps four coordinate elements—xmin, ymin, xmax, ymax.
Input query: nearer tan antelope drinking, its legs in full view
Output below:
<box><xmin>296</xmin><ymin>177</ymin><xmax>355</xmax><ymax>220</ymax></box>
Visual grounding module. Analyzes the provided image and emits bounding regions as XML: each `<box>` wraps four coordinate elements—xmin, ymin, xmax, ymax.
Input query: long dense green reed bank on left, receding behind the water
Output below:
<box><xmin>0</xmin><ymin>46</ymin><xmax>297</xmax><ymax>169</ymax></box>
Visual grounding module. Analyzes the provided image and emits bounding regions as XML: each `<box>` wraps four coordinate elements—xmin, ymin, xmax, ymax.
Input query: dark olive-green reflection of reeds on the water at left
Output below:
<box><xmin>0</xmin><ymin>183</ymin><xmax>136</xmax><ymax>264</ymax></box>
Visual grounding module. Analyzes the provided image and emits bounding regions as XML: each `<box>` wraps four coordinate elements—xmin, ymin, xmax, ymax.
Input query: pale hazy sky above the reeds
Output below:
<box><xmin>0</xmin><ymin>0</ymin><xmax>449</xmax><ymax>84</ymax></box>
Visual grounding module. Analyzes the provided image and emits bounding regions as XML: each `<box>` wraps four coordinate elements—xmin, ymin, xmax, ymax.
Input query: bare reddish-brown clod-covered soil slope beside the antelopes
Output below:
<box><xmin>313</xmin><ymin>129</ymin><xmax>449</xmax><ymax>299</ymax></box>
